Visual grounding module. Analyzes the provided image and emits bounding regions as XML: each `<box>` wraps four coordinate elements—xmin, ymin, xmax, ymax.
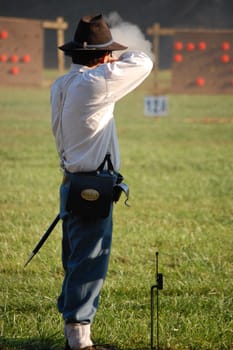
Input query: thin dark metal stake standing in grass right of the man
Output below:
<box><xmin>150</xmin><ymin>252</ymin><xmax>163</xmax><ymax>350</ymax></box>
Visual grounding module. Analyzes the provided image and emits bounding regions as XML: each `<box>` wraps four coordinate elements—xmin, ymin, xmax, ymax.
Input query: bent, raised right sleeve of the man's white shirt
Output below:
<box><xmin>103</xmin><ymin>51</ymin><xmax>153</xmax><ymax>102</ymax></box>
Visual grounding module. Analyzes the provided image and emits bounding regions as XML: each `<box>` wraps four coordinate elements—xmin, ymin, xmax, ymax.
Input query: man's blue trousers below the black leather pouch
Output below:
<box><xmin>58</xmin><ymin>208</ymin><xmax>112</xmax><ymax>323</ymax></box>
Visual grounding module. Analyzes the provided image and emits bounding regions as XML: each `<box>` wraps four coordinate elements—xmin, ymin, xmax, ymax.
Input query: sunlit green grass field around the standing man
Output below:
<box><xmin>0</xmin><ymin>72</ymin><xmax>233</xmax><ymax>350</ymax></box>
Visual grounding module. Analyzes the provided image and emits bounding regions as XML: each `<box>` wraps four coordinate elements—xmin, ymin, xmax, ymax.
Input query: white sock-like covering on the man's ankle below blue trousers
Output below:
<box><xmin>65</xmin><ymin>323</ymin><xmax>93</xmax><ymax>350</ymax></box>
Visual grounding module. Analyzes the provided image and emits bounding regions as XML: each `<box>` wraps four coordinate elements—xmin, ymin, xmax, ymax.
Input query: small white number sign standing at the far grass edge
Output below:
<box><xmin>144</xmin><ymin>96</ymin><xmax>168</xmax><ymax>117</ymax></box>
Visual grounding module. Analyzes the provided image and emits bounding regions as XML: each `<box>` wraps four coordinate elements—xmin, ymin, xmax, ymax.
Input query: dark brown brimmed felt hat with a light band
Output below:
<box><xmin>59</xmin><ymin>14</ymin><xmax>127</xmax><ymax>52</ymax></box>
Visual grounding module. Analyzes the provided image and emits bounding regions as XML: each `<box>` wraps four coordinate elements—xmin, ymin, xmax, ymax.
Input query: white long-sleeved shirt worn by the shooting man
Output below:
<box><xmin>51</xmin><ymin>51</ymin><xmax>153</xmax><ymax>172</ymax></box>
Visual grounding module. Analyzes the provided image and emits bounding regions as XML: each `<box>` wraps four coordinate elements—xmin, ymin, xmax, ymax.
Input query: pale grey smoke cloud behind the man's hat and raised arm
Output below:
<box><xmin>106</xmin><ymin>12</ymin><xmax>155</xmax><ymax>61</ymax></box>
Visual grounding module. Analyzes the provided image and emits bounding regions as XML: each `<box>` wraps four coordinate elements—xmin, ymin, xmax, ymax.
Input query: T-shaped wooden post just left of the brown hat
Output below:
<box><xmin>43</xmin><ymin>17</ymin><xmax>68</xmax><ymax>75</ymax></box>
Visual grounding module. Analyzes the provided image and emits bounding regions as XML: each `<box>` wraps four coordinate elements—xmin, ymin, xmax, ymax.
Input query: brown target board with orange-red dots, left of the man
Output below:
<box><xmin>0</xmin><ymin>17</ymin><xmax>44</xmax><ymax>86</ymax></box>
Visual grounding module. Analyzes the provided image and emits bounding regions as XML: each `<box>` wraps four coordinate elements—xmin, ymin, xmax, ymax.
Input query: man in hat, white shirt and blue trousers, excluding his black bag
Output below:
<box><xmin>51</xmin><ymin>15</ymin><xmax>153</xmax><ymax>350</ymax></box>
